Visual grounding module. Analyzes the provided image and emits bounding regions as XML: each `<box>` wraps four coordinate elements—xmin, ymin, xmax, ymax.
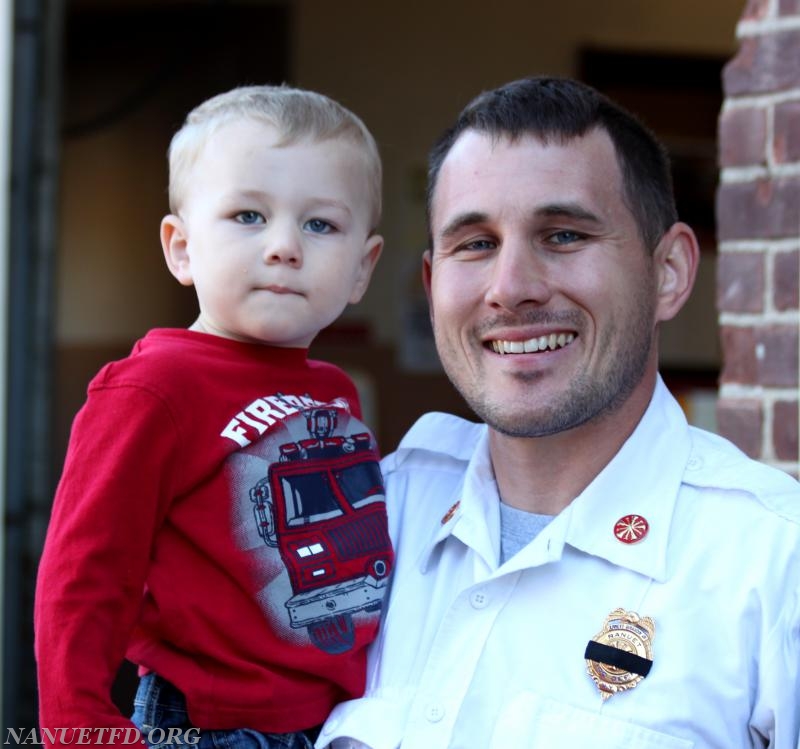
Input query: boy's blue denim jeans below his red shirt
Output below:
<box><xmin>131</xmin><ymin>673</ymin><xmax>314</xmax><ymax>749</ymax></box>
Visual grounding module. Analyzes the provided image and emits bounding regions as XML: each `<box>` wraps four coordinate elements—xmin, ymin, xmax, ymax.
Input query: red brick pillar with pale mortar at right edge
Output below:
<box><xmin>717</xmin><ymin>0</ymin><xmax>800</xmax><ymax>476</ymax></box>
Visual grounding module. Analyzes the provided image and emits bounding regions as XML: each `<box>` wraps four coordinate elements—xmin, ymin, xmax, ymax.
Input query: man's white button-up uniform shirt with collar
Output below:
<box><xmin>317</xmin><ymin>381</ymin><xmax>800</xmax><ymax>749</ymax></box>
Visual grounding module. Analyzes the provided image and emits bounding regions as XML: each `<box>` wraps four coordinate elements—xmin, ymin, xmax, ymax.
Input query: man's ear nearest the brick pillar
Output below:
<box><xmin>653</xmin><ymin>221</ymin><xmax>700</xmax><ymax>322</ymax></box>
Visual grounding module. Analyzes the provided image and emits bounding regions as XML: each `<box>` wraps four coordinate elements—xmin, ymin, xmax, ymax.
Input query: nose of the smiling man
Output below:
<box><xmin>485</xmin><ymin>237</ymin><xmax>553</xmax><ymax>310</ymax></box>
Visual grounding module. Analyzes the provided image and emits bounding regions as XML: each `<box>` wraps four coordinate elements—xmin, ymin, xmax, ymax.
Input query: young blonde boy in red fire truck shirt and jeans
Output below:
<box><xmin>35</xmin><ymin>86</ymin><xmax>392</xmax><ymax>747</ymax></box>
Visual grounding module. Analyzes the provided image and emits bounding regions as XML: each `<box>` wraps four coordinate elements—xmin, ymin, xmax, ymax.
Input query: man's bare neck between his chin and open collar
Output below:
<box><xmin>489</xmin><ymin>376</ymin><xmax>655</xmax><ymax>515</ymax></box>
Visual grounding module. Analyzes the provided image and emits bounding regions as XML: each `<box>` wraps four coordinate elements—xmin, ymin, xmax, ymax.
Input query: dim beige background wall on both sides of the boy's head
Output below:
<box><xmin>57</xmin><ymin>0</ymin><xmax>743</xmax><ymax>349</ymax></box>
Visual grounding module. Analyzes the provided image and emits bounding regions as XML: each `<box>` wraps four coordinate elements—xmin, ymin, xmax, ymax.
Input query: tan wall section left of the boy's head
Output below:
<box><xmin>56</xmin><ymin>118</ymin><xmax>188</xmax><ymax>344</ymax></box>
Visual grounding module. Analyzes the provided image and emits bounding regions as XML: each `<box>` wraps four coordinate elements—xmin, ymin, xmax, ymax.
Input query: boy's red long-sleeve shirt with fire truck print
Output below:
<box><xmin>35</xmin><ymin>329</ymin><xmax>392</xmax><ymax>732</ymax></box>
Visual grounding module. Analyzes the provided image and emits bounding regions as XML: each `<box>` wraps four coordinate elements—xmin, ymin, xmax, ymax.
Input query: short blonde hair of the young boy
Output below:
<box><xmin>168</xmin><ymin>85</ymin><xmax>382</xmax><ymax>230</ymax></box>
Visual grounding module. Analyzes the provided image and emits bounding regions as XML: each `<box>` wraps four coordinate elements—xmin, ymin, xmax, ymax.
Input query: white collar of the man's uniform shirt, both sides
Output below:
<box><xmin>422</xmin><ymin>376</ymin><xmax>691</xmax><ymax>581</ymax></box>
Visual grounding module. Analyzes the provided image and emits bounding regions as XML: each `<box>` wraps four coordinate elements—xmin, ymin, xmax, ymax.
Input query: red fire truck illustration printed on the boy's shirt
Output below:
<box><xmin>250</xmin><ymin>408</ymin><xmax>392</xmax><ymax>653</ymax></box>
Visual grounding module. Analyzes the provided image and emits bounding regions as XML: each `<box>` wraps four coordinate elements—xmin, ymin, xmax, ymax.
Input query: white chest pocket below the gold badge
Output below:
<box><xmin>490</xmin><ymin>692</ymin><xmax>694</xmax><ymax>749</ymax></box>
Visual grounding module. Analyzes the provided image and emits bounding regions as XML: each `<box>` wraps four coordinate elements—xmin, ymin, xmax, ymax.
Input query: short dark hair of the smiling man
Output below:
<box><xmin>427</xmin><ymin>76</ymin><xmax>678</xmax><ymax>251</ymax></box>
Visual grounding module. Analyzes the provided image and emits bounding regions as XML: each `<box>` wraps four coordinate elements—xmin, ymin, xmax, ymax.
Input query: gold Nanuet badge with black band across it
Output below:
<box><xmin>583</xmin><ymin>609</ymin><xmax>656</xmax><ymax>700</ymax></box>
